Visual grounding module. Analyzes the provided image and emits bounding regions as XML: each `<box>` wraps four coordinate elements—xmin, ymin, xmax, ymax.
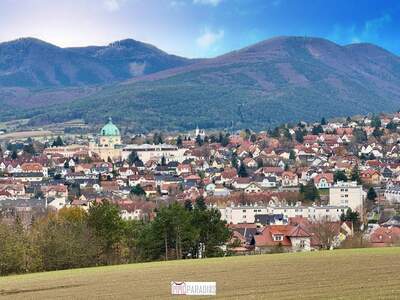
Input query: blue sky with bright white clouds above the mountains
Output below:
<box><xmin>0</xmin><ymin>0</ymin><xmax>400</xmax><ymax>57</ymax></box>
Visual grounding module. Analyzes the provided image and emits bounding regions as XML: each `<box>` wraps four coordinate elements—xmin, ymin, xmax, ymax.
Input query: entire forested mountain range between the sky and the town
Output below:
<box><xmin>0</xmin><ymin>37</ymin><xmax>400</xmax><ymax>130</ymax></box>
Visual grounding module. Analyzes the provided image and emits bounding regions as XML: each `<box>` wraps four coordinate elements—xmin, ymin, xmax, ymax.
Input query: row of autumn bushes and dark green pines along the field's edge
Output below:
<box><xmin>0</xmin><ymin>199</ymin><xmax>230</xmax><ymax>275</ymax></box>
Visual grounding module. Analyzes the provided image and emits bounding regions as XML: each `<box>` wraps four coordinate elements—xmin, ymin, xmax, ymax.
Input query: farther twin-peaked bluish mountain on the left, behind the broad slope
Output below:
<box><xmin>0</xmin><ymin>38</ymin><xmax>189</xmax><ymax>88</ymax></box>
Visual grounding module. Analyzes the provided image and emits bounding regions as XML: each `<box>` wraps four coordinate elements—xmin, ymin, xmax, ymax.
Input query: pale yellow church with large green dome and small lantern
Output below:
<box><xmin>90</xmin><ymin>118</ymin><xmax>122</xmax><ymax>161</ymax></box>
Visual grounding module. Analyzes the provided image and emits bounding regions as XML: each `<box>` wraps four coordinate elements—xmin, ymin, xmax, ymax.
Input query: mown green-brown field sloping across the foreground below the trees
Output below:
<box><xmin>0</xmin><ymin>248</ymin><xmax>400</xmax><ymax>299</ymax></box>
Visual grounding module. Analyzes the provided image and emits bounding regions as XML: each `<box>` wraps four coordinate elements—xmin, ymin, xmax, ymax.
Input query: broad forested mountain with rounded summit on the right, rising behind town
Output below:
<box><xmin>0</xmin><ymin>37</ymin><xmax>400</xmax><ymax>130</ymax></box>
